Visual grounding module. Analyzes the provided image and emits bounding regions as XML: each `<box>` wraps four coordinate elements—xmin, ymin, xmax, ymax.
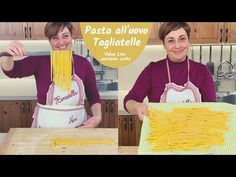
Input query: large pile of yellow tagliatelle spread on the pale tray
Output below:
<box><xmin>148</xmin><ymin>107</ymin><xmax>230</xmax><ymax>151</ymax></box>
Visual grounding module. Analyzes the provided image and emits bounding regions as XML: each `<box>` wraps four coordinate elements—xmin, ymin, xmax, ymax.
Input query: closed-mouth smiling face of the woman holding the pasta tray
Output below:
<box><xmin>164</xmin><ymin>28</ymin><xmax>189</xmax><ymax>62</ymax></box>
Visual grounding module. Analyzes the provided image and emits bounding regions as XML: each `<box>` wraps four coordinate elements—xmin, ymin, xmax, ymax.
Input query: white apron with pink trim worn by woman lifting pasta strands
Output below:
<box><xmin>32</xmin><ymin>69</ymin><xmax>87</xmax><ymax>128</ymax></box>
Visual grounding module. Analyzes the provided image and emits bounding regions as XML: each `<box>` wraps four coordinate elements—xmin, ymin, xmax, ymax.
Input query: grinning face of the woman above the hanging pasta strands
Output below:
<box><xmin>49</xmin><ymin>27</ymin><xmax>72</xmax><ymax>50</ymax></box>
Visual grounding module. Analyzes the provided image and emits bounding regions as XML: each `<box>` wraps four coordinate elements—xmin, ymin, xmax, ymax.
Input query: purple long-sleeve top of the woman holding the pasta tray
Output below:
<box><xmin>124</xmin><ymin>58</ymin><xmax>216</xmax><ymax>111</ymax></box>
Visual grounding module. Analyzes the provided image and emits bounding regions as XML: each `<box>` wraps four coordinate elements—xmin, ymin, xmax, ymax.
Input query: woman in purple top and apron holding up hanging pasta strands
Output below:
<box><xmin>1</xmin><ymin>22</ymin><xmax>102</xmax><ymax>128</ymax></box>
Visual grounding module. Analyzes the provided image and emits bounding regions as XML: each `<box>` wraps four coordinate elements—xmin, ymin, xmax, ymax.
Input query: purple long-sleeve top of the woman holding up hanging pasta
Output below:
<box><xmin>3</xmin><ymin>54</ymin><xmax>100</xmax><ymax>105</ymax></box>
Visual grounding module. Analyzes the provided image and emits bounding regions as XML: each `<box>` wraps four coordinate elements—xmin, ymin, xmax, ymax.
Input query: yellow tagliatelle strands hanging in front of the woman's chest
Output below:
<box><xmin>51</xmin><ymin>51</ymin><xmax>72</xmax><ymax>92</ymax></box>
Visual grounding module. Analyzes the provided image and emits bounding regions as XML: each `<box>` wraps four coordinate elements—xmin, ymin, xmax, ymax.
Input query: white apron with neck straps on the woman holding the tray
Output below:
<box><xmin>160</xmin><ymin>59</ymin><xmax>201</xmax><ymax>103</ymax></box>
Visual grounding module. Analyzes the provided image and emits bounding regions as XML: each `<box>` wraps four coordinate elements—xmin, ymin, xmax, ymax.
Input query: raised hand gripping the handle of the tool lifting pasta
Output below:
<box><xmin>6</xmin><ymin>41</ymin><xmax>27</xmax><ymax>56</ymax></box>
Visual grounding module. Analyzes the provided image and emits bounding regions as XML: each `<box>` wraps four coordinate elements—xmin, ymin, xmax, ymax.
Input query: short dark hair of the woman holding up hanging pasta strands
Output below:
<box><xmin>44</xmin><ymin>22</ymin><xmax>74</xmax><ymax>40</ymax></box>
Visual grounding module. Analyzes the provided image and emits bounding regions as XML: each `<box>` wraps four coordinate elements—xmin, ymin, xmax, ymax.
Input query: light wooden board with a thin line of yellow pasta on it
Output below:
<box><xmin>0</xmin><ymin>128</ymin><xmax>118</xmax><ymax>154</ymax></box>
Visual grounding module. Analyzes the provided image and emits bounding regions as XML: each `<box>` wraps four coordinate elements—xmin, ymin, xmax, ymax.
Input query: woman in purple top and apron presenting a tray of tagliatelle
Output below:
<box><xmin>124</xmin><ymin>22</ymin><xmax>216</xmax><ymax>120</ymax></box>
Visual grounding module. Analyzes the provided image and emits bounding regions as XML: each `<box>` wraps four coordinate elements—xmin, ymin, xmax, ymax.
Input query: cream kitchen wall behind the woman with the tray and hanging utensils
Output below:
<box><xmin>118</xmin><ymin>44</ymin><xmax>236</xmax><ymax>92</ymax></box>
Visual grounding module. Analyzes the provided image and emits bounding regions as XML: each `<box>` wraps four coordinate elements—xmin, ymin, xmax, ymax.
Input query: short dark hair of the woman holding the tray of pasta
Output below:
<box><xmin>159</xmin><ymin>22</ymin><xmax>191</xmax><ymax>42</ymax></box>
